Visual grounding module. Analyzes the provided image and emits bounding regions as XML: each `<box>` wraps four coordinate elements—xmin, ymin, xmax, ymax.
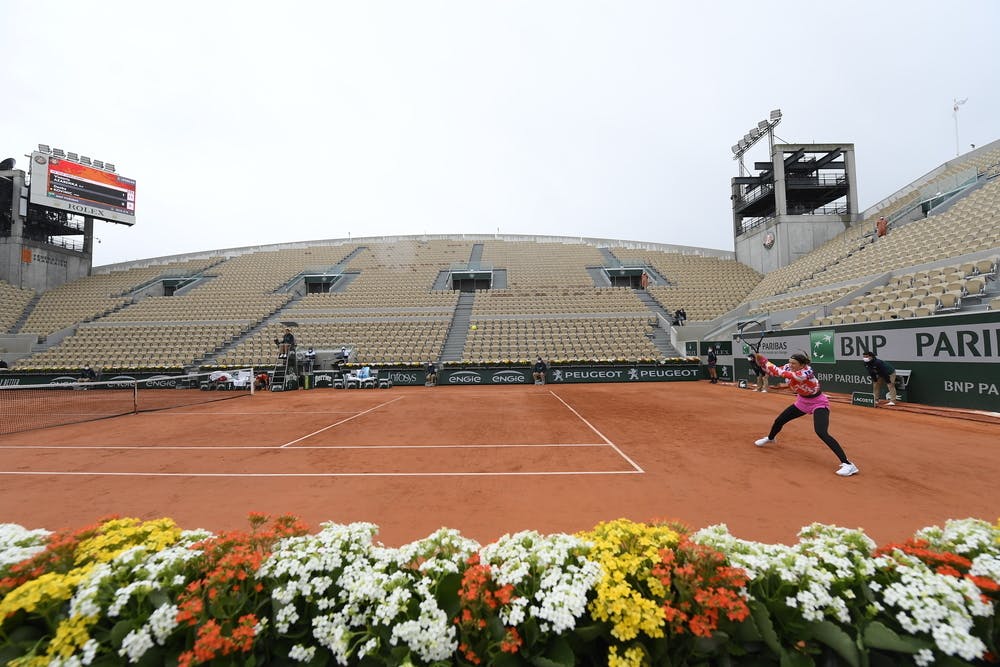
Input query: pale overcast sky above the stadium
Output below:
<box><xmin>0</xmin><ymin>0</ymin><xmax>1000</xmax><ymax>265</ymax></box>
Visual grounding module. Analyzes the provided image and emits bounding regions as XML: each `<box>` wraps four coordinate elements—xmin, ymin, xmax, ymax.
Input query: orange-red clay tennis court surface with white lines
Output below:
<box><xmin>0</xmin><ymin>382</ymin><xmax>1000</xmax><ymax>545</ymax></box>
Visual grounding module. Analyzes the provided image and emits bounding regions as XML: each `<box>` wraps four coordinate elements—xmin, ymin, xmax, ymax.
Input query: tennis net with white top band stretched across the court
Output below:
<box><xmin>0</xmin><ymin>368</ymin><xmax>254</xmax><ymax>434</ymax></box>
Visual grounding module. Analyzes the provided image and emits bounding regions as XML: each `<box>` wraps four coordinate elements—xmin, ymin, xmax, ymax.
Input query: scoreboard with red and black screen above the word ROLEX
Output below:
<box><xmin>31</xmin><ymin>152</ymin><xmax>135</xmax><ymax>225</ymax></box>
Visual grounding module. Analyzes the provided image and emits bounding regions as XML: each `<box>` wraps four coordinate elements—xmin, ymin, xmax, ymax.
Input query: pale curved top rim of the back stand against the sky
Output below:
<box><xmin>93</xmin><ymin>234</ymin><xmax>736</xmax><ymax>273</ymax></box>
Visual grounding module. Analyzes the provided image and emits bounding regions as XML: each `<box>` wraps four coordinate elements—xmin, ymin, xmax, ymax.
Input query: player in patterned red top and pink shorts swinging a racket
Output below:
<box><xmin>754</xmin><ymin>353</ymin><xmax>858</xmax><ymax>477</ymax></box>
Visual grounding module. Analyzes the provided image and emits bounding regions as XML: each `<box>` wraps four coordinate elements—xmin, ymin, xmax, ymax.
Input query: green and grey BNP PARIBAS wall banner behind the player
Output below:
<box><xmin>733</xmin><ymin>311</ymin><xmax>1000</xmax><ymax>412</ymax></box>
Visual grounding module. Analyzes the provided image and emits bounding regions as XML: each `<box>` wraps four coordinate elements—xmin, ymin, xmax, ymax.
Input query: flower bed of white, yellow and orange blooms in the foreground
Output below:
<box><xmin>0</xmin><ymin>514</ymin><xmax>1000</xmax><ymax>667</ymax></box>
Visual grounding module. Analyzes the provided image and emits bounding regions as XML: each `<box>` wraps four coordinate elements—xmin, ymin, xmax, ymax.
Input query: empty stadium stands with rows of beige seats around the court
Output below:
<box><xmin>7</xmin><ymin>142</ymin><xmax>1000</xmax><ymax>371</ymax></box>
